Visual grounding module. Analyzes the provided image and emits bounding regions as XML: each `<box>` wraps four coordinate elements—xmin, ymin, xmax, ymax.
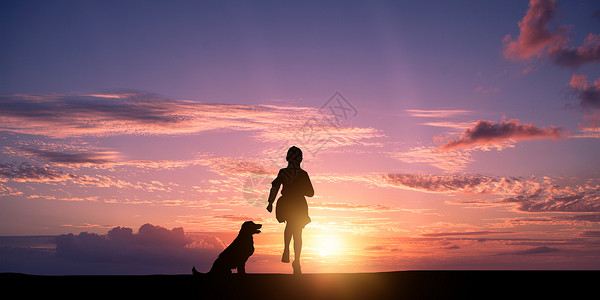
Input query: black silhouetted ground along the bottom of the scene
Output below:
<box><xmin>0</xmin><ymin>271</ymin><xmax>600</xmax><ymax>300</ymax></box>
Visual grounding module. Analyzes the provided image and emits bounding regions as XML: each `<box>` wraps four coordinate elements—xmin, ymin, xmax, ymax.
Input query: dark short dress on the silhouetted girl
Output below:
<box><xmin>271</xmin><ymin>168</ymin><xmax>314</xmax><ymax>227</ymax></box>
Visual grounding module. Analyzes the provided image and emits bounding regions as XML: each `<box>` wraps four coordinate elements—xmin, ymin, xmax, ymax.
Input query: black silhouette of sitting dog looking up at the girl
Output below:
<box><xmin>192</xmin><ymin>221</ymin><xmax>262</xmax><ymax>275</ymax></box>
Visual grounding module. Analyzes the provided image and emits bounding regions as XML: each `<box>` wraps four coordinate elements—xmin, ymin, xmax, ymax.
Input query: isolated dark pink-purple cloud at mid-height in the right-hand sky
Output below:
<box><xmin>439</xmin><ymin>120</ymin><xmax>566</xmax><ymax>151</ymax></box>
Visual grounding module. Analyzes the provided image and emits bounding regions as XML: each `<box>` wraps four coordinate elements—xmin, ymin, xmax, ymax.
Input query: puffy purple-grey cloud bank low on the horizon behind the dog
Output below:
<box><xmin>56</xmin><ymin>224</ymin><xmax>223</xmax><ymax>274</ymax></box>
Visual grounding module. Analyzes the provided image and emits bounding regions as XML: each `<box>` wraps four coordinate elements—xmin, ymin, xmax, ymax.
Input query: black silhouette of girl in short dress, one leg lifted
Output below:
<box><xmin>267</xmin><ymin>146</ymin><xmax>315</xmax><ymax>274</ymax></box>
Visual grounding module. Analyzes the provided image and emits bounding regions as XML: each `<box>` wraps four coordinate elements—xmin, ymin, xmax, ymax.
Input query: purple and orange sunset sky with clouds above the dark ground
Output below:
<box><xmin>0</xmin><ymin>0</ymin><xmax>600</xmax><ymax>274</ymax></box>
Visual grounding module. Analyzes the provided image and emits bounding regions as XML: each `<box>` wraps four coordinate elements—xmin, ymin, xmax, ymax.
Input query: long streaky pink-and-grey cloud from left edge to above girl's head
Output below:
<box><xmin>0</xmin><ymin>92</ymin><xmax>381</xmax><ymax>147</ymax></box>
